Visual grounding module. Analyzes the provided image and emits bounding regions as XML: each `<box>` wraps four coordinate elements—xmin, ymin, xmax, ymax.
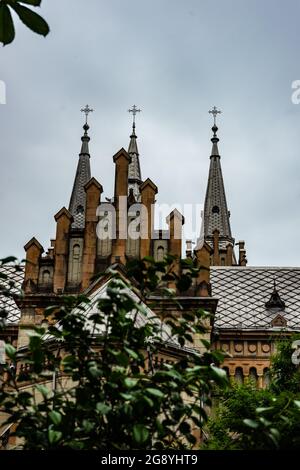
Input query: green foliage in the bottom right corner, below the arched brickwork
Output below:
<box><xmin>204</xmin><ymin>336</ymin><xmax>300</xmax><ymax>450</ymax></box>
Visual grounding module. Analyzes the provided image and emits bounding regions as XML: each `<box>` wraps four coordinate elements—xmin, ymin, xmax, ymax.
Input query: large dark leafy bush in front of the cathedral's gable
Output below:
<box><xmin>0</xmin><ymin>258</ymin><xmax>226</xmax><ymax>449</ymax></box>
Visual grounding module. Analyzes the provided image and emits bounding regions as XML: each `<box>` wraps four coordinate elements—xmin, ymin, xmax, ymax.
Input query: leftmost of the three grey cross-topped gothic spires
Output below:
<box><xmin>69</xmin><ymin>105</ymin><xmax>93</xmax><ymax>228</ymax></box>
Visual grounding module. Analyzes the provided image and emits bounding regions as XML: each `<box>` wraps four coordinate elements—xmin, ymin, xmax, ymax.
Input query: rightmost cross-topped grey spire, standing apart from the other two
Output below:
<box><xmin>199</xmin><ymin>106</ymin><xmax>234</xmax><ymax>260</ymax></box>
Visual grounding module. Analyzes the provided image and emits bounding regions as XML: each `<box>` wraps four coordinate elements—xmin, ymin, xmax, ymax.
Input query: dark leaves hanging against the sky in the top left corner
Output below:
<box><xmin>0</xmin><ymin>0</ymin><xmax>49</xmax><ymax>46</ymax></box>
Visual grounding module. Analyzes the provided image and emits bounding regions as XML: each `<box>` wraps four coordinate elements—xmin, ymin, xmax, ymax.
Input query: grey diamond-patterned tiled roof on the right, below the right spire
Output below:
<box><xmin>211</xmin><ymin>266</ymin><xmax>300</xmax><ymax>330</ymax></box>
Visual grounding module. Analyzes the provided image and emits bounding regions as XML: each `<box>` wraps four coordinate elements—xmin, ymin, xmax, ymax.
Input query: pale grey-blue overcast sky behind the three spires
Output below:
<box><xmin>0</xmin><ymin>0</ymin><xmax>300</xmax><ymax>266</ymax></box>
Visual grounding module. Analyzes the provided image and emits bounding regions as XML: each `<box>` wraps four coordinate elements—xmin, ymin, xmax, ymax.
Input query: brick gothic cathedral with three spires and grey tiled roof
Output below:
<box><xmin>0</xmin><ymin>106</ymin><xmax>300</xmax><ymax>387</ymax></box>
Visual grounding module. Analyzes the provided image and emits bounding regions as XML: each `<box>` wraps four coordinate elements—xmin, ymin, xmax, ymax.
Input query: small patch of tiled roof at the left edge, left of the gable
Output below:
<box><xmin>0</xmin><ymin>264</ymin><xmax>24</xmax><ymax>325</ymax></box>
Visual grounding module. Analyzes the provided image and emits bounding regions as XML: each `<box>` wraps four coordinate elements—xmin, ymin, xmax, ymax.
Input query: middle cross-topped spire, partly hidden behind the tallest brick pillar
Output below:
<box><xmin>128</xmin><ymin>105</ymin><xmax>142</xmax><ymax>201</ymax></box>
